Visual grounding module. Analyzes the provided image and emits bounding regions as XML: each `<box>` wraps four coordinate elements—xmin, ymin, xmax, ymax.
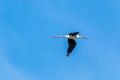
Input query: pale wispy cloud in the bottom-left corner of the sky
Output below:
<box><xmin>0</xmin><ymin>50</ymin><xmax>32</xmax><ymax>80</ymax></box>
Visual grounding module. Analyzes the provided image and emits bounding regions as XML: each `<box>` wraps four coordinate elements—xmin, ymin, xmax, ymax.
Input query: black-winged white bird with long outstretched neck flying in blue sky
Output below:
<box><xmin>53</xmin><ymin>32</ymin><xmax>87</xmax><ymax>57</ymax></box>
